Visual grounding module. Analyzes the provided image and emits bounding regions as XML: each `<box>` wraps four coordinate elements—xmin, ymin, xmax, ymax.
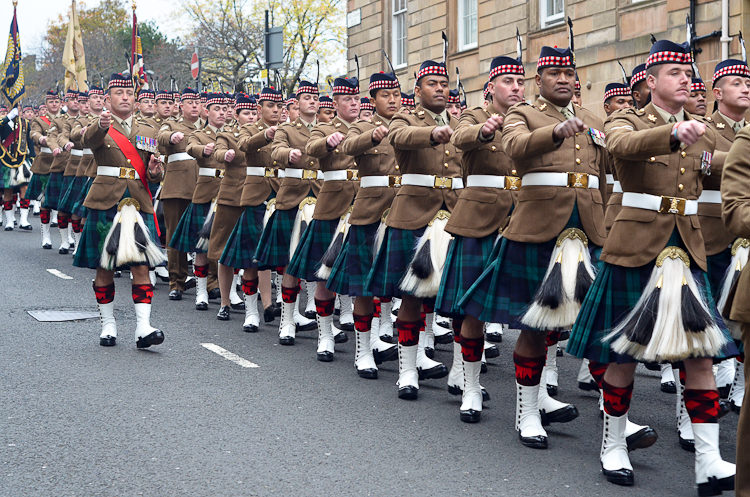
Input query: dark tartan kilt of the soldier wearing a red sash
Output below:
<box><xmin>73</xmin><ymin>190</ymin><xmax>158</xmax><ymax>270</ymax></box>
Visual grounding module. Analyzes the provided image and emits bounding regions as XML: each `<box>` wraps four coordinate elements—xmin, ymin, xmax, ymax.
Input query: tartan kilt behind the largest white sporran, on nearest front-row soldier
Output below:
<box><xmin>567</xmin><ymin>235</ymin><xmax>739</xmax><ymax>363</ymax></box>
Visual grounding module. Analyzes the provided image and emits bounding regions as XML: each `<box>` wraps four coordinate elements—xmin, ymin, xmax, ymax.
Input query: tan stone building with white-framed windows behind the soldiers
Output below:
<box><xmin>347</xmin><ymin>0</ymin><xmax>750</xmax><ymax>114</ymax></box>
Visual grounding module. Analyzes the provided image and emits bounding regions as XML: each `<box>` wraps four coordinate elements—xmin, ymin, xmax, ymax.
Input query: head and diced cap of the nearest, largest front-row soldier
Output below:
<box><xmin>646</xmin><ymin>40</ymin><xmax>693</xmax><ymax>110</ymax></box>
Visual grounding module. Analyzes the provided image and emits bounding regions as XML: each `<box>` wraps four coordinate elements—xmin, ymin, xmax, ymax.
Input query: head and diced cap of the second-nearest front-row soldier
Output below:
<box><xmin>535</xmin><ymin>47</ymin><xmax>576</xmax><ymax>107</ymax></box>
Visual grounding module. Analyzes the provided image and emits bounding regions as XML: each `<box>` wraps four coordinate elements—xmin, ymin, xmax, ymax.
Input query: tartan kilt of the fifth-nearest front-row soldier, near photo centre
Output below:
<box><xmin>326</xmin><ymin>221</ymin><xmax>380</xmax><ymax>297</ymax></box>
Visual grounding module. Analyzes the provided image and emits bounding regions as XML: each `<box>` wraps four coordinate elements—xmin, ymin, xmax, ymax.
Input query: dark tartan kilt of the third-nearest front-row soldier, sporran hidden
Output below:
<box><xmin>435</xmin><ymin>233</ymin><xmax>497</xmax><ymax>318</ymax></box>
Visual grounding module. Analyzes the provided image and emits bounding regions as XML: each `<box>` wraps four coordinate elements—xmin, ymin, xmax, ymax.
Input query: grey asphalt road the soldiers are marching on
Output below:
<box><xmin>0</xmin><ymin>220</ymin><xmax>737</xmax><ymax>497</ymax></box>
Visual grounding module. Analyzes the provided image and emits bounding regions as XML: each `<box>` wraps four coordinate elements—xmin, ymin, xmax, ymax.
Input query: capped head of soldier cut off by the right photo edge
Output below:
<box><xmin>713</xmin><ymin>59</ymin><xmax>750</xmax><ymax>117</ymax></box>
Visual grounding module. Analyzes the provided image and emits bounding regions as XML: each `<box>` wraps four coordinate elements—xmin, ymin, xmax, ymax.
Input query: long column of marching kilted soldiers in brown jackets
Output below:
<box><xmin>1</xmin><ymin>28</ymin><xmax>750</xmax><ymax>496</ymax></box>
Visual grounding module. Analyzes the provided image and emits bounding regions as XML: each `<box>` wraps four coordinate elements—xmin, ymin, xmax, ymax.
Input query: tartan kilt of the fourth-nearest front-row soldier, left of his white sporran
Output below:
<box><xmin>365</xmin><ymin>226</ymin><xmax>427</xmax><ymax>297</ymax></box>
